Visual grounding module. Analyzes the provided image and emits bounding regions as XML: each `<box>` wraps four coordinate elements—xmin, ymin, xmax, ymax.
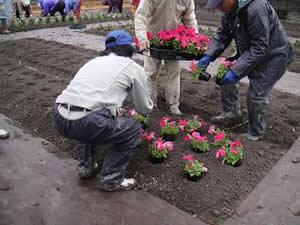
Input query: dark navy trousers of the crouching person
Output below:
<box><xmin>53</xmin><ymin>104</ymin><xmax>141</xmax><ymax>187</ymax></box>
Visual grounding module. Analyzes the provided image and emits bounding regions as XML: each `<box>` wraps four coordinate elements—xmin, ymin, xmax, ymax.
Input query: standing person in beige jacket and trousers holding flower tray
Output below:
<box><xmin>134</xmin><ymin>0</ymin><xmax>198</xmax><ymax>115</ymax></box>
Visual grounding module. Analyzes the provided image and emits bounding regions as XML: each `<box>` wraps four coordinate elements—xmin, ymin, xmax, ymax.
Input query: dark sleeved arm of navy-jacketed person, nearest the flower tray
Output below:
<box><xmin>205</xmin><ymin>15</ymin><xmax>233</xmax><ymax>61</ymax></box>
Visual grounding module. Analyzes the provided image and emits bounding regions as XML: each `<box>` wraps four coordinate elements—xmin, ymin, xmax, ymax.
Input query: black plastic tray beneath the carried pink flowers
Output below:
<box><xmin>150</xmin><ymin>48</ymin><xmax>202</xmax><ymax>60</ymax></box>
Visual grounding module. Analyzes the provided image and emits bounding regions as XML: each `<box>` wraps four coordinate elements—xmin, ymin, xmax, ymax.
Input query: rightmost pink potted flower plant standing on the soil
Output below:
<box><xmin>216</xmin><ymin>140</ymin><xmax>243</xmax><ymax>167</ymax></box>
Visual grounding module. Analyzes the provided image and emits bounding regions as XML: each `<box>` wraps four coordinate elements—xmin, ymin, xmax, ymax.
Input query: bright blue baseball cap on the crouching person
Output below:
<box><xmin>105</xmin><ymin>30</ymin><xmax>133</xmax><ymax>48</ymax></box>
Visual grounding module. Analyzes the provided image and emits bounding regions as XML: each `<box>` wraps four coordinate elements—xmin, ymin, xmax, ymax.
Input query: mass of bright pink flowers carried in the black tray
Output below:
<box><xmin>147</xmin><ymin>25</ymin><xmax>210</xmax><ymax>56</ymax></box>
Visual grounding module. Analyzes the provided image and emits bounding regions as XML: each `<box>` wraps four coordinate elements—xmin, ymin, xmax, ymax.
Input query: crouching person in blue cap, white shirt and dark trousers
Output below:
<box><xmin>54</xmin><ymin>30</ymin><xmax>153</xmax><ymax>191</ymax></box>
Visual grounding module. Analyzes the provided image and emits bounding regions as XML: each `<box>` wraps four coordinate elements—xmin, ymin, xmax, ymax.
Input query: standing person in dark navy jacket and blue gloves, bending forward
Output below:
<box><xmin>198</xmin><ymin>0</ymin><xmax>293</xmax><ymax>141</ymax></box>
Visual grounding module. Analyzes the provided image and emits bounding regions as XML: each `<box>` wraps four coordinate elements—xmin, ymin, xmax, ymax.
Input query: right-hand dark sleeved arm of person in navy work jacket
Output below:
<box><xmin>231</xmin><ymin>8</ymin><xmax>271</xmax><ymax>79</ymax></box>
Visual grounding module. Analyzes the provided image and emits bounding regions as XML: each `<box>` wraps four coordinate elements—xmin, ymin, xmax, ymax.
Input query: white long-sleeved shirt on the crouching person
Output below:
<box><xmin>56</xmin><ymin>54</ymin><xmax>153</xmax><ymax>119</ymax></box>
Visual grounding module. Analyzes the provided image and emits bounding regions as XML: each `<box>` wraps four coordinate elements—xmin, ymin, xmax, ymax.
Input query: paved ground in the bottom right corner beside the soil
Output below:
<box><xmin>224</xmin><ymin>137</ymin><xmax>300</xmax><ymax>225</ymax></box>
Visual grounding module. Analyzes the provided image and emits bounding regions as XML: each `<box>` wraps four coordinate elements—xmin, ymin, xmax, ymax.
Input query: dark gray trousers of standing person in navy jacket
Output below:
<box><xmin>221</xmin><ymin>56</ymin><xmax>287</xmax><ymax>136</ymax></box>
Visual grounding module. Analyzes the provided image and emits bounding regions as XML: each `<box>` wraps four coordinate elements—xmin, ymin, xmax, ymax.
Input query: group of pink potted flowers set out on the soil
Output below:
<box><xmin>129</xmin><ymin>109</ymin><xmax>243</xmax><ymax>181</ymax></box>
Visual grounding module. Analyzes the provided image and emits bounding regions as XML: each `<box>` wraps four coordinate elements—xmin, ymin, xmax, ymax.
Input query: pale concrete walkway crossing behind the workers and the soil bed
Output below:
<box><xmin>0</xmin><ymin>21</ymin><xmax>300</xmax><ymax>96</ymax></box>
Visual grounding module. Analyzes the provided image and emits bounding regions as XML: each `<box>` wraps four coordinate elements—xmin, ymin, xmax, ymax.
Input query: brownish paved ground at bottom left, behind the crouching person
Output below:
<box><xmin>0</xmin><ymin>115</ymin><xmax>205</xmax><ymax>225</ymax></box>
